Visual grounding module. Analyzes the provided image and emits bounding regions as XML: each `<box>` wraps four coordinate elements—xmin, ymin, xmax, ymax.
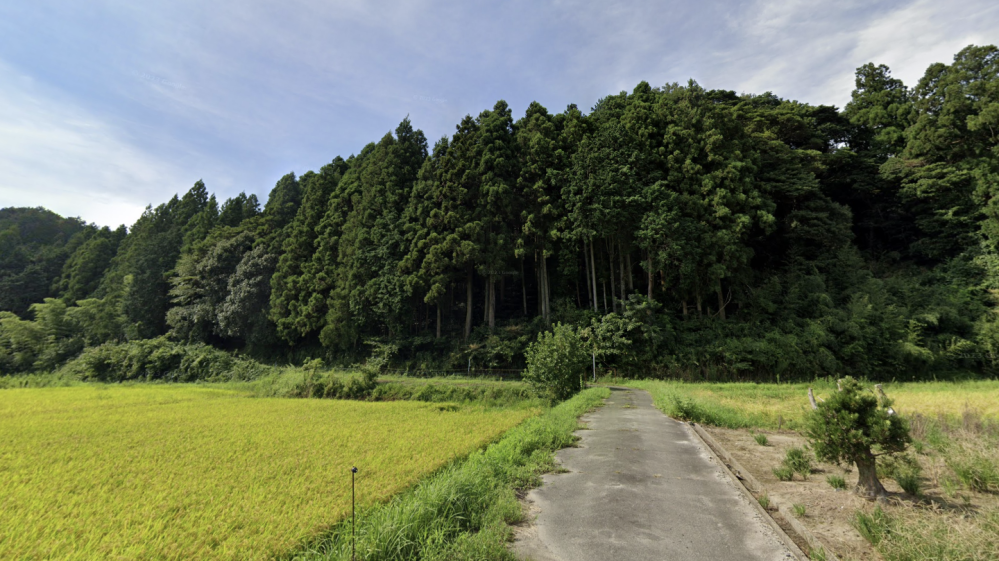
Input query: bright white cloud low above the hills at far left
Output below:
<box><xmin>0</xmin><ymin>63</ymin><xmax>186</xmax><ymax>226</ymax></box>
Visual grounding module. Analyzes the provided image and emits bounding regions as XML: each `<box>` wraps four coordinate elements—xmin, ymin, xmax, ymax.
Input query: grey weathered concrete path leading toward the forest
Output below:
<box><xmin>514</xmin><ymin>389</ymin><xmax>795</xmax><ymax>561</ymax></box>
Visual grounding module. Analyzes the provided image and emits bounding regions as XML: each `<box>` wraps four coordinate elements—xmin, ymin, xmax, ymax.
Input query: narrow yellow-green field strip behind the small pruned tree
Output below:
<box><xmin>626</xmin><ymin>380</ymin><xmax>999</xmax><ymax>429</ymax></box>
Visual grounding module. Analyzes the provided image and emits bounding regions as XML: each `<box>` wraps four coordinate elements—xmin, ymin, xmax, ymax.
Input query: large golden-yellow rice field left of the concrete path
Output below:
<box><xmin>0</xmin><ymin>386</ymin><xmax>531</xmax><ymax>560</ymax></box>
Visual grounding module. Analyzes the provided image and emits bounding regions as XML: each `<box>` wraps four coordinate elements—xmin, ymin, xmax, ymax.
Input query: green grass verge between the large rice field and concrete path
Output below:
<box><xmin>286</xmin><ymin>388</ymin><xmax>610</xmax><ymax>561</ymax></box>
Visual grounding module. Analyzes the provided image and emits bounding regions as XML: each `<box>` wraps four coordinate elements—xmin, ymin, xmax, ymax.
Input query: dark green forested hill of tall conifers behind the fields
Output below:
<box><xmin>0</xmin><ymin>46</ymin><xmax>999</xmax><ymax>379</ymax></box>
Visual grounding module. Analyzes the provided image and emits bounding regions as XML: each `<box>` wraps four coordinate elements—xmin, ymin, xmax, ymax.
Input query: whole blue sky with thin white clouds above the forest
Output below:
<box><xmin>0</xmin><ymin>0</ymin><xmax>999</xmax><ymax>227</ymax></box>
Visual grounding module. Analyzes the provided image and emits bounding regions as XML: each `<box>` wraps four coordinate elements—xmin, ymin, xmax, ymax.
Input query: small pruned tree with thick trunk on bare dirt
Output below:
<box><xmin>805</xmin><ymin>376</ymin><xmax>911</xmax><ymax>500</ymax></box>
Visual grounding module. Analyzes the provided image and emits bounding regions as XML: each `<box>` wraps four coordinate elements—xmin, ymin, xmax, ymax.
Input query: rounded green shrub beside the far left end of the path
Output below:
<box><xmin>524</xmin><ymin>323</ymin><xmax>589</xmax><ymax>402</ymax></box>
